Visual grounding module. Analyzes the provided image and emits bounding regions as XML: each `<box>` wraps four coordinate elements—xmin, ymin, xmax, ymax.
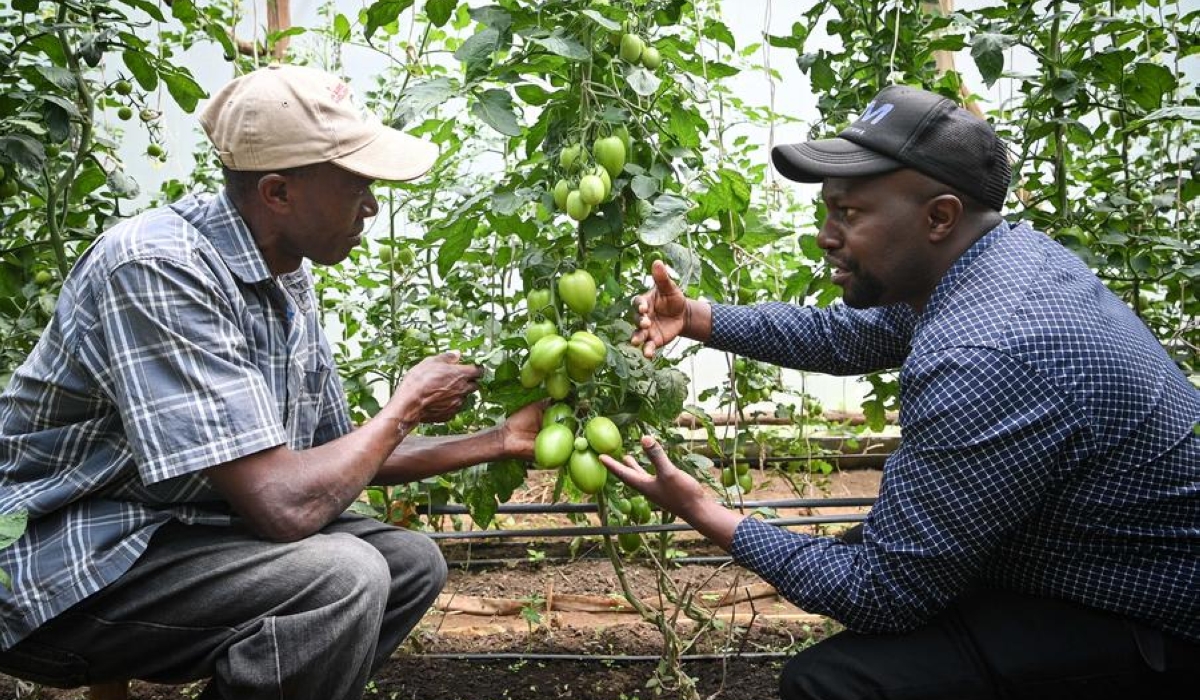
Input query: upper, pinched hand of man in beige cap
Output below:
<box><xmin>392</xmin><ymin>352</ymin><xmax>484</xmax><ymax>424</ymax></box>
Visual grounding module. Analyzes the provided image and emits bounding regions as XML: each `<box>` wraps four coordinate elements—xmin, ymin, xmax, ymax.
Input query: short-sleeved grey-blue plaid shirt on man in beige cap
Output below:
<box><xmin>0</xmin><ymin>195</ymin><xmax>350</xmax><ymax>648</ymax></box>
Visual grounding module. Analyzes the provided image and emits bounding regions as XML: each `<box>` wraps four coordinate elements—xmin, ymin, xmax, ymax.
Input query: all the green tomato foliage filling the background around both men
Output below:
<box><xmin>0</xmin><ymin>8</ymin><xmax>1200</xmax><ymax>693</ymax></box>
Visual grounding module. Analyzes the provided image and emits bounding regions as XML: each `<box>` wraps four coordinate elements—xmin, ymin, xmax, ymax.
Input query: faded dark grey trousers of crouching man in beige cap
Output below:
<box><xmin>0</xmin><ymin>515</ymin><xmax>446</xmax><ymax>700</ymax></box>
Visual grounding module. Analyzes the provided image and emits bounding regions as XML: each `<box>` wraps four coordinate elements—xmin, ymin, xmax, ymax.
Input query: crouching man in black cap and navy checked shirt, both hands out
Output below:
<box><xmin>604</xmin><ymin>86</ymin><xmax>1200</xmax><ymax>700</ymax></box>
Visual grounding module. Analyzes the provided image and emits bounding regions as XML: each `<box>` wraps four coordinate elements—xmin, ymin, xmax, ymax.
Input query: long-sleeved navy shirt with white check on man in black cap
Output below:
<box><xmin>709</xmin><ymin>223</ymin><xmax>1200</xmax><ymax>640</ymax></box>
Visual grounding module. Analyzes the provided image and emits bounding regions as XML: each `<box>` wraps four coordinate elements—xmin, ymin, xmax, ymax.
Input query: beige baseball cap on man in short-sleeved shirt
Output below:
<box><xmin>200</xmin><ymin>64</ymin><xmax>438</xmax><ymax>180</ymax></box>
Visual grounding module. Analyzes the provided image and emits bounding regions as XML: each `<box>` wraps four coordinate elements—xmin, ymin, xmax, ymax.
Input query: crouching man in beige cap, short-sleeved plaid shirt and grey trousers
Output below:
<box><xmin>0</xmin><ymin>66</ymin><xmax>540</xmax><ymax>700</ymax></box>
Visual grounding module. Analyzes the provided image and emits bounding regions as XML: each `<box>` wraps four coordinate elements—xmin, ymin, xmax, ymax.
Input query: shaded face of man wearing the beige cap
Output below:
<box><xmin>282</xmin><ymin>163</ymin><xmax>379</xmax><ymax>265</ymax></box>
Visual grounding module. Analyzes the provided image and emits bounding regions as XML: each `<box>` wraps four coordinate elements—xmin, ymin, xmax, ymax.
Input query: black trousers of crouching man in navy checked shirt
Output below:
<box><xmin>780</xmin><ymin>525</ymin><xmax>1200</xmax><ymax>700</ymax></box>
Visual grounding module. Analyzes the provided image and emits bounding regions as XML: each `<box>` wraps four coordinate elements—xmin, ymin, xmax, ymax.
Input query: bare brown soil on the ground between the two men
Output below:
<box><xmin>0</xmin><ymin>469</ymin><xmax>880</xmax><ymax>700</ymax></box>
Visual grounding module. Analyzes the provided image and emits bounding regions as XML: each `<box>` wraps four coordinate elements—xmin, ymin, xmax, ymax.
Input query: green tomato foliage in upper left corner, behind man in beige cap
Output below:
<box><xmin>0</xmin><ymin>0</ymin><xmax>211</xmax><ymax>387</ymax></box>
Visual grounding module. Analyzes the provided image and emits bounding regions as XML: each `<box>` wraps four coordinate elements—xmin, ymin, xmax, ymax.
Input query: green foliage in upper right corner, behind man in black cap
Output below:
<box><xmin>768</xmin><ymin>0</ymin><xmax>1200</xmax><ymax>424</ymax></box>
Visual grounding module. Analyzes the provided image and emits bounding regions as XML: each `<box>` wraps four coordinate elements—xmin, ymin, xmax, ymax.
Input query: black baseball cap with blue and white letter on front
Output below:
<box><xmin>770</xmin><ymin>85</ymin><xmax>1012</xmax><ymax>211</ymax></box>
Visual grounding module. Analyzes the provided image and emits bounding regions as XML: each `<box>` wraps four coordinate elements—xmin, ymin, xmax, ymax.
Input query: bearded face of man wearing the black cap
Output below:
<box><xmin>817</xmin><ymin>169</ymin><xmax>941</xmax><ymax>311</ymax></box>
